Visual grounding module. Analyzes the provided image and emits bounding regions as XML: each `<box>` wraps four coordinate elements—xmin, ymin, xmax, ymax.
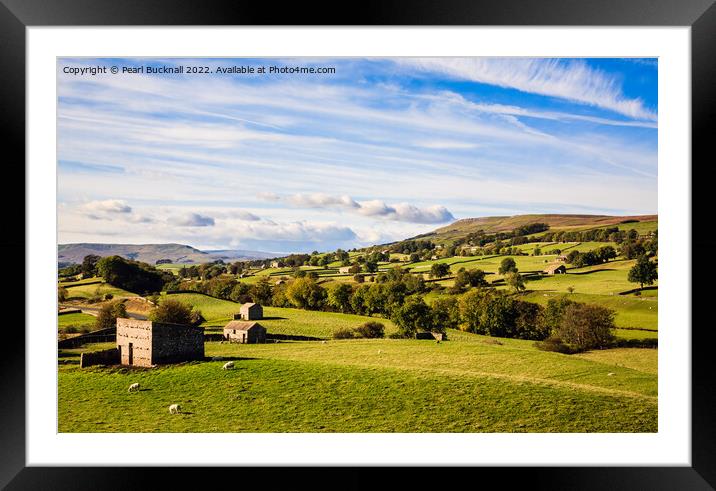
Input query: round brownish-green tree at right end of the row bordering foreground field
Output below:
<box><xmin>556</xmin><ymin>303</ymin><xmax>615</xmax><ymax>351</ymax></box>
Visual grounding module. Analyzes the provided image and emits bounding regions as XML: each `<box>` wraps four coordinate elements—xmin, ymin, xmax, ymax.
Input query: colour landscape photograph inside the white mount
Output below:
<box><xmin>58</xmin><ymin>56</ymin><xmax>656</xmax><ymax>434</ymax></box>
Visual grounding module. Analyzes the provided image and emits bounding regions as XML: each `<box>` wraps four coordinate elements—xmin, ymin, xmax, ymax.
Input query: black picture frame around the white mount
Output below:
<box><xmin>0</xmin><ymin>0</ymin><xmax>716</xmax><ymax>489</ymax></box>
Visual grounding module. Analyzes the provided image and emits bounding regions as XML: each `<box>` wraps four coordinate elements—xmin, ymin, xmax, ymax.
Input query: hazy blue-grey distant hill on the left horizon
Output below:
<box><xmin>57</xmin><ymin>243</ymin><xmax>277</xmax><ymax>264</ymax></box>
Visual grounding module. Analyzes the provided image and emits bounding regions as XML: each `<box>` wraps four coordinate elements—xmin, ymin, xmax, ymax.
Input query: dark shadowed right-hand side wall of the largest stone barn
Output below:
<box><xmin>152</xmin><ymin>322</ymin><xmax>204</xmax><ymax>364</ymax></box>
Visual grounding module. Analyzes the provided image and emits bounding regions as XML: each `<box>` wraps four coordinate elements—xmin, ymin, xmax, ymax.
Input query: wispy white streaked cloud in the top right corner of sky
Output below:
<box><xmin>396</xmin><ymin>58</ymin><xmax>656</xmax><ymax>121</ymax></box>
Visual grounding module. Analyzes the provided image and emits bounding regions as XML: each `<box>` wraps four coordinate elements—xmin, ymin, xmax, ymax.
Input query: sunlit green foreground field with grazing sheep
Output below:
<box><xmin>58</xmin><ymin>332</ymin><xmax>657</xmax><ymax>432</ymax></box>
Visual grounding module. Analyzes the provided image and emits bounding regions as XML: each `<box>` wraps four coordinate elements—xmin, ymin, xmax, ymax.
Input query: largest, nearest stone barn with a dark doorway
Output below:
<box><xmin>117</xmin><ymin>318</ymin><xmax>204</xmax><ymax>367</ymax></box>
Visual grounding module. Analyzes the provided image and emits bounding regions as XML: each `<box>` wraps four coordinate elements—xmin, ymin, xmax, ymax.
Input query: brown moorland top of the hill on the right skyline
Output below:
<box><xmin>416</xmin><ymin>214</ymin><xmax>658</xmax><ymax>244</ymax></box>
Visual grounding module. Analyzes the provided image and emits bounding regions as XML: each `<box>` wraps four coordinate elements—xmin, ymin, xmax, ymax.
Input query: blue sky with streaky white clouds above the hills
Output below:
<box><xmin>57</xmin><ymin>58</ymin><xmax>658</xmax><ymax>253</ymax></box>
